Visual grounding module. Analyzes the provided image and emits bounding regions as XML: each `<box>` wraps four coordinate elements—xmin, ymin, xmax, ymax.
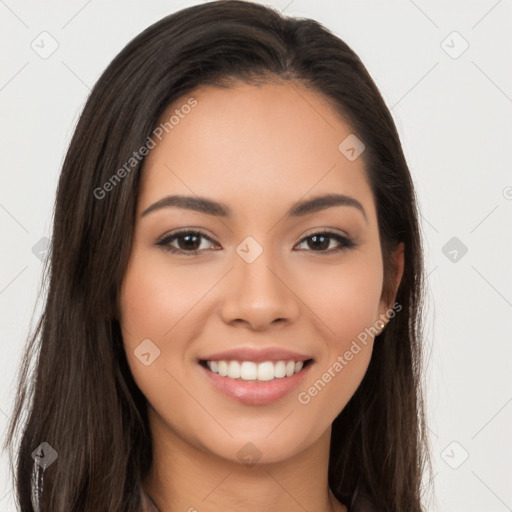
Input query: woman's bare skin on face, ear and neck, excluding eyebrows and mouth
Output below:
<box><xmin>119</xmin><ymin>83</ymin><xmax>403</xmax><ymax>512</ymax></box>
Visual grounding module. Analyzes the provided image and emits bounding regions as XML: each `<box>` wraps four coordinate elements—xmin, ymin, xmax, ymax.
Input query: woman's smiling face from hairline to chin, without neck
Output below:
<box><xmin>119</xmin><ymin>80</ymin><xmax>402</xmax><ymax>462</ymax></box>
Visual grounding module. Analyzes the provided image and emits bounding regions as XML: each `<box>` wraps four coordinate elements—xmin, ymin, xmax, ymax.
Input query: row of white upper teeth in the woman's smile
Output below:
<box><xmin>206</xmin><ymin>361</ymin><xmax>304</xmax><ymax>380</ymax></box>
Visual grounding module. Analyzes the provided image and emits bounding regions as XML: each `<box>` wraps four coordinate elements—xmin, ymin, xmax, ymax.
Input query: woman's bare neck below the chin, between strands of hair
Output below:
<box><xmin>143</xmin><ymin>407</ymin><xmax>347</xmax><ymax>512</ymax></box>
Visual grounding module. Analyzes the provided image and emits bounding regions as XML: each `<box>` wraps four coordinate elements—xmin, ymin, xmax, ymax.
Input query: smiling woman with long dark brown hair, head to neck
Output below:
<box><xmin>3</xmin><ymin>0</ymin><xmax>429</xmax><ymax>512</ymax></box>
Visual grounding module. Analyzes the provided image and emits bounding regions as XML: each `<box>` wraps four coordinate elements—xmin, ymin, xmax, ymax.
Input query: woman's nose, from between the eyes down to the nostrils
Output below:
<box><xmin>221</xmin><ymin>245</ymin><xmax>300</xmax><ymax>331</ymax></box>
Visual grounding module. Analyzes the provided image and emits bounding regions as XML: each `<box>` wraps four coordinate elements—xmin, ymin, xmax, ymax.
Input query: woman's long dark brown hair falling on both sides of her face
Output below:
<box><xmin>5</xmin><ymin>0</ymin><xmax>430</xmax><ymax>512</ymax></box>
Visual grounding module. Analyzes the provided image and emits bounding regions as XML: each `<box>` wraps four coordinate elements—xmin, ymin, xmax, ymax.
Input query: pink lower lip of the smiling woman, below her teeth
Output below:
<box><xmin>199</xmin><ymin>362</ymin><xmax>313</xmax><ymax>405</ymax></box>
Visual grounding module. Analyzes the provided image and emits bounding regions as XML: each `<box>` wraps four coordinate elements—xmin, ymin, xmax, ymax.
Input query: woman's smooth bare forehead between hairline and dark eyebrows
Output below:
<box><xmin>139</xmin><ymin>83</ymin><xmax>373</xmax><ymax>220</ymax></box>
